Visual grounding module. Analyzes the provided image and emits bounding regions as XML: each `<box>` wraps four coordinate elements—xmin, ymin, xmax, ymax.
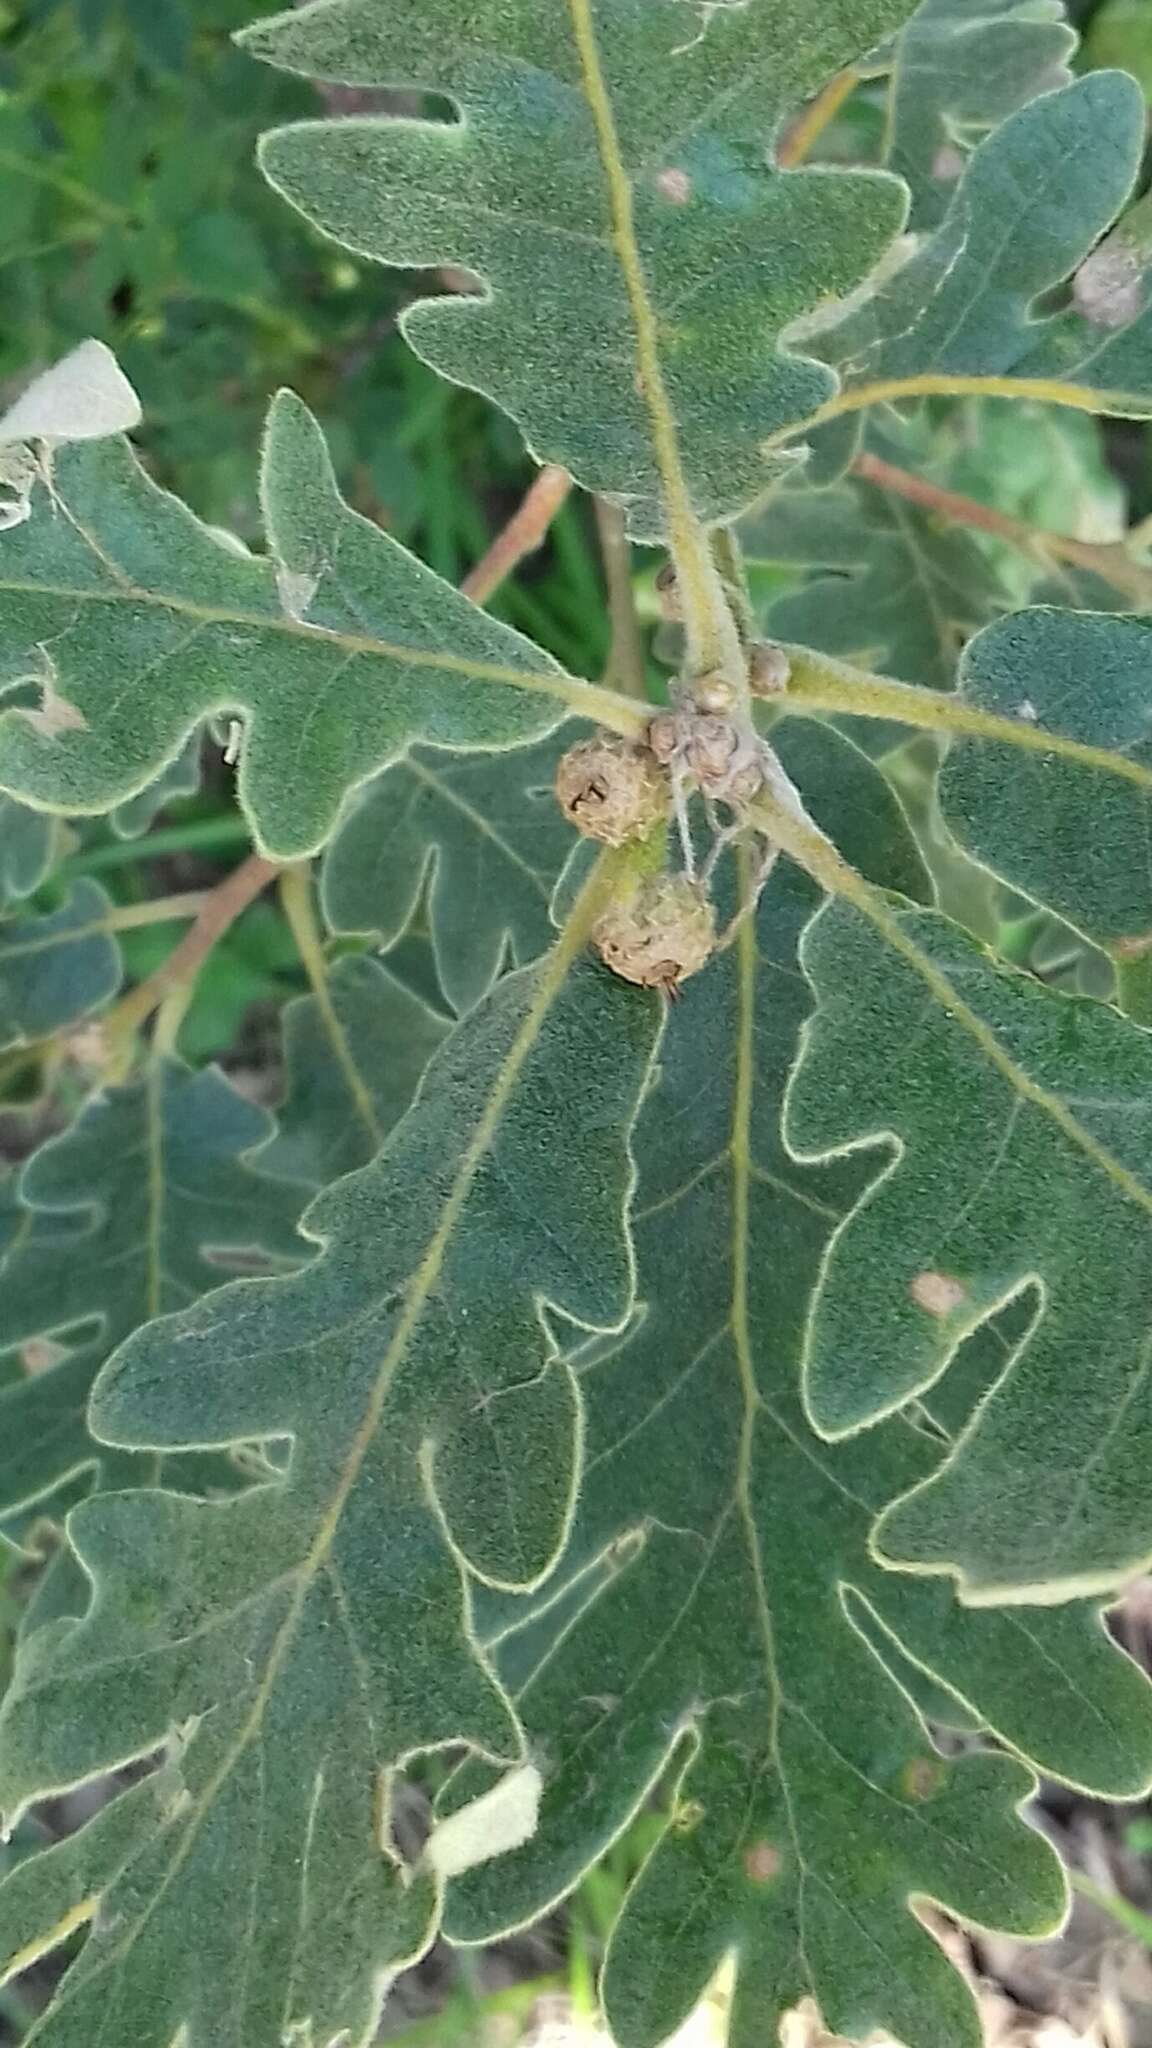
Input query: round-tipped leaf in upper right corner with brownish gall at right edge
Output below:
<box><xmin>820</xmin><ymin>72</ymin><xmax>1152</xmax><ymax>414</ymax></box>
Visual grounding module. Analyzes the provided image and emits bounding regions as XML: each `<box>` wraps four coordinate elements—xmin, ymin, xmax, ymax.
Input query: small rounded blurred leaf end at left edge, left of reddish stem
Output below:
<box><xmin>0</xmin><ymin>879</ymin><xmax>121</xmax><ymax>1047</ymax></box>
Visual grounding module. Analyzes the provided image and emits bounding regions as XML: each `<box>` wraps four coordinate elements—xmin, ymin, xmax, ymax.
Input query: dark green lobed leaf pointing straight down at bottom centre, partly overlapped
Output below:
<box><xmin>447</xmin><ymin>868</ymin><xmax>1152</xmax><ymax>2048</ymax></box>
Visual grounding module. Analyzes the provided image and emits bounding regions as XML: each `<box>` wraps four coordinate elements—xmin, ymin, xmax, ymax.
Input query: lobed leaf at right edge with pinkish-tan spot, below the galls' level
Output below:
<box><xmin>785</xmin><ymin>905</ymin><xmax>1152</xmax><ymax>1602</ymax></box>
